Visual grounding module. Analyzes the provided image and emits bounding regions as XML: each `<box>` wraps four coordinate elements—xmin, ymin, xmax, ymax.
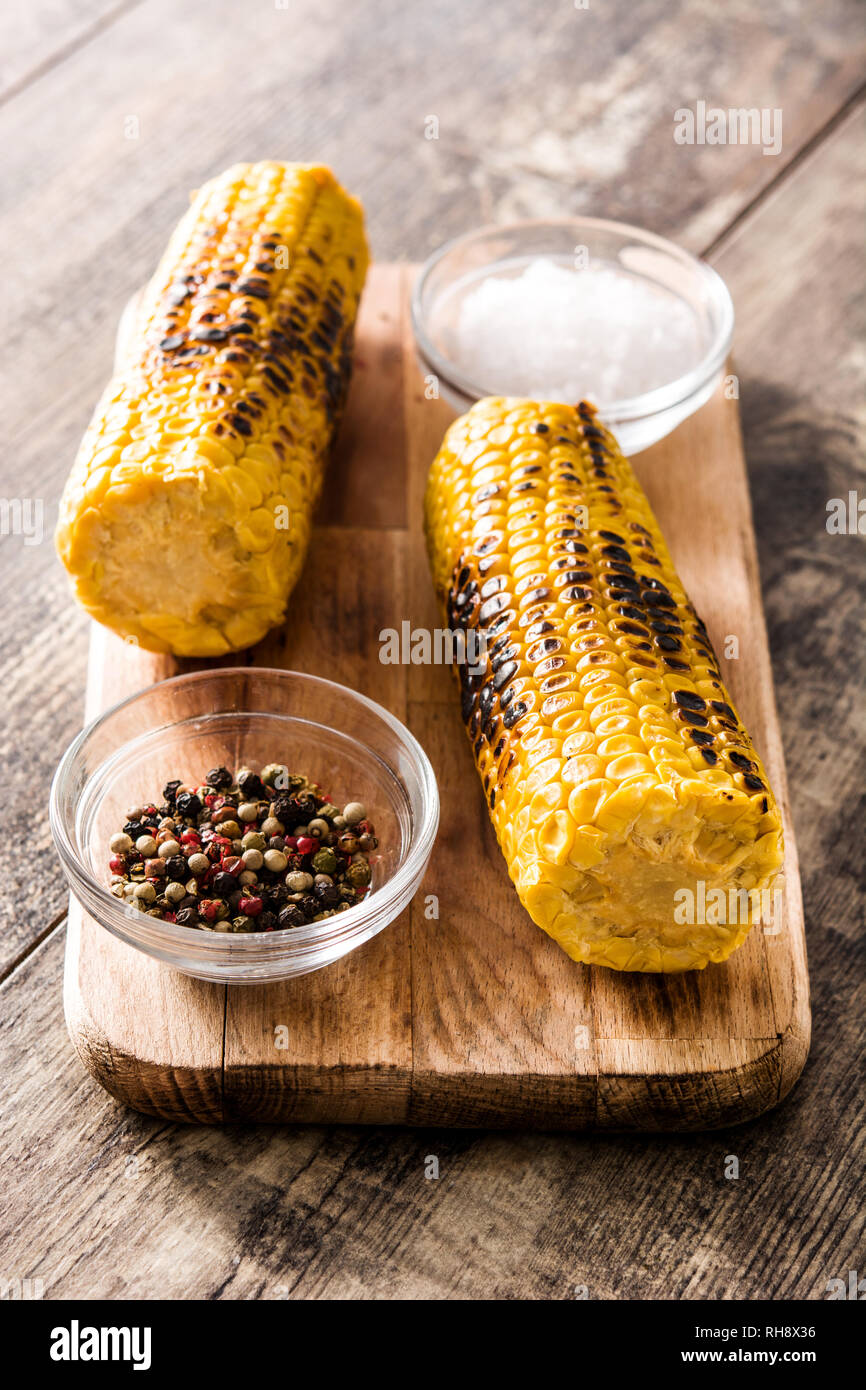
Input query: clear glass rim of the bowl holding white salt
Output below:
<box><xmin>410</xmin><ymin>214</ymin><xmax>734</xmax><ymax>425</ymax></box>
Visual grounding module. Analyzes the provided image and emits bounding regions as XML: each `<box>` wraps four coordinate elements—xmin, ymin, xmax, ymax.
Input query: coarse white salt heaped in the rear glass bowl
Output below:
<box><xmin>449</xmin><ymin>257</ymin><xmax>702</xmax><ymax>406</ymax></box>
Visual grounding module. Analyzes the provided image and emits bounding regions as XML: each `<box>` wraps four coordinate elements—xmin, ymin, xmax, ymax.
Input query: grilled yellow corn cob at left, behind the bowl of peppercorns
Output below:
<box><xmin>57</xmin><ymin>163</ymin><xmax>367</xmax><ymax>656</ymax></box>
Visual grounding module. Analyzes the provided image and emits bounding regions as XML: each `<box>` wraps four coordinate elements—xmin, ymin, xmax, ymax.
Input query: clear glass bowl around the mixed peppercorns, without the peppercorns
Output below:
<box><xmin>51</xmin><ymin>667</ymin><xmax>439</xmax><ymax>983</ymax></box>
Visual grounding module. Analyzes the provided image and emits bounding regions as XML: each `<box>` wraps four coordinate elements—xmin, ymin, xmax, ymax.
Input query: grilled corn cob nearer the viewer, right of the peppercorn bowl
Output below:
<box><xmin>425</xmin><ymin>399</ymin><xmax>783</xmax><ymax>972</ymax></box>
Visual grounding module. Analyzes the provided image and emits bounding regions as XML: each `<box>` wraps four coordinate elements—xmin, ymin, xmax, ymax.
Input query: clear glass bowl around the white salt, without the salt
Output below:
<box><xmin>411</xmin><ymin>217</ymin><xmax>734</xmax><ymax>455</ymax></box>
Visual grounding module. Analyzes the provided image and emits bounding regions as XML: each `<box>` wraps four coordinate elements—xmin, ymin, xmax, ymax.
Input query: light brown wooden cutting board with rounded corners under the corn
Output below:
<box><xmin>65</xmin><ymin>265</ymin><xmax>809</xmax><ymax>1130</ymax></box>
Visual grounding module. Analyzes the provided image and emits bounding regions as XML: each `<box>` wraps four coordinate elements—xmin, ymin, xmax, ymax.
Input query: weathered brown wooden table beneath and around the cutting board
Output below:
<box><xmin>0</xmin><ymin>0</ymin><xmax>866</xmax><ymax>1300</ymax></box>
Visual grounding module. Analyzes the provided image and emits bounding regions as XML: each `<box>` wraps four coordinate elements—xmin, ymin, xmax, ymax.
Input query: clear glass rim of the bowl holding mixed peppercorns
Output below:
<box><xmin>49</xmin><ymin>666</ymin><xmax>439</xmax><ymax>958</ymax></box>
